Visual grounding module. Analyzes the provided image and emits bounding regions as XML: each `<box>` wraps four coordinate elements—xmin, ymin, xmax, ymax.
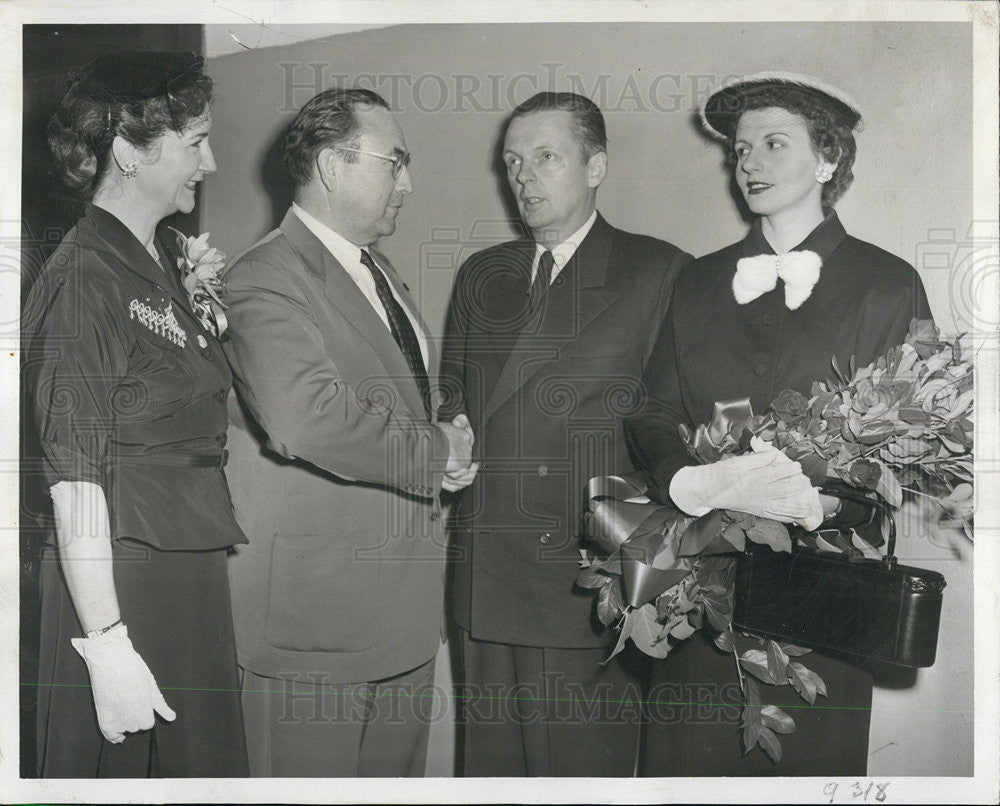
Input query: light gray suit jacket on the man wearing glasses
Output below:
<box><xmin>225</xmin><ymin>211</ymin><xmax>448</xmax><ymax>683</ymax></box>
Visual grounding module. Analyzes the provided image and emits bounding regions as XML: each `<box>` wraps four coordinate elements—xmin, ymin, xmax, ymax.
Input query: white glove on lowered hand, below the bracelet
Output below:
<box><xmin>70</xmin><ymin>624</ymin><xmax>177</xmax><ymax>744</ymax></box>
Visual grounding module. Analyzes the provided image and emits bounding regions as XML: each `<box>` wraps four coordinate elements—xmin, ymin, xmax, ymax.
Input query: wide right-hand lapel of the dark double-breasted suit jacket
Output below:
<box><xmin>484</xmin><ymin>215</ymin><xmax>620</xmax><ymax>420</ymax></box>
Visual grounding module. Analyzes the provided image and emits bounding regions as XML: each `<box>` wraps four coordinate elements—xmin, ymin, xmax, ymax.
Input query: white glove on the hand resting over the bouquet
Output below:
<box><xmin>670</xmin><ymin>440</ymin><xmax>823</xmax><ymax>530</ymax></box>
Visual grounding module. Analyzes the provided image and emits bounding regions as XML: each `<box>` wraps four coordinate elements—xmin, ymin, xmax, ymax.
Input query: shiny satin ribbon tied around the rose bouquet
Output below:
<box><xmin>587</xmin><ymin>398</ymin><xmax>753</xmax><ymax>607</ymax></box>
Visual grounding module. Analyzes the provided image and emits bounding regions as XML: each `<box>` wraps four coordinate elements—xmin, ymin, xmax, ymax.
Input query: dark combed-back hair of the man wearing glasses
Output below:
<box><xmin>281</xmin><ymin>88</ymin><xmax>389</xmax><ymax>187</ymax></box>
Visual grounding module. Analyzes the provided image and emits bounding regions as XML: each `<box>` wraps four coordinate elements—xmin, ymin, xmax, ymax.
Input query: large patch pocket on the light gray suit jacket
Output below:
<box><xmin>264</xmin><ymin>533</ymin><xmax>379</xmax><ymax>652</ymax></box>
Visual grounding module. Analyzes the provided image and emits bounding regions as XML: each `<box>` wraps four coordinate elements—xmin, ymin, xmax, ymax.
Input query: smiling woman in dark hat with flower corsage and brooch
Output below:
<box><xmin>24</xmin><ymin>52</ymin><xmax>247</xmax><ymax>778</ymax></box>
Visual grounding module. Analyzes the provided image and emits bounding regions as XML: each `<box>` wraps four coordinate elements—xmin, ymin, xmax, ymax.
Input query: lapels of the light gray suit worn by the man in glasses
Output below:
<box><xmin>281</xmin><ymin>210</ymin><xmax>427</xmax><ymax>416</ymax></box>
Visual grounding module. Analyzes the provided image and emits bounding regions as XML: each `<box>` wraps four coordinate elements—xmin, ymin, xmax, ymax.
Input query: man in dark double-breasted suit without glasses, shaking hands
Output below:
<box><xmin>442</xmin><ymin>93</ymin><xmax>690</xmax><ymax>776</ymax></box>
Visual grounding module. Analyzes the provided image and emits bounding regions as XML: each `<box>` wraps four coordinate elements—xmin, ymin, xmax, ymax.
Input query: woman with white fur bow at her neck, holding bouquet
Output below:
<box><xmin>627</xmin><ymin>73</ymin><xmax>930</xmax><ymax>776</ymax></box>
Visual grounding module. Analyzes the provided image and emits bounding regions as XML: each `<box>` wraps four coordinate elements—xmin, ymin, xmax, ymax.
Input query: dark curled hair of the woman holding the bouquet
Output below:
<box><xmin>727</xmin><ymin>86</ymin><xmax>857</xmax><ymax>208</ymax></box>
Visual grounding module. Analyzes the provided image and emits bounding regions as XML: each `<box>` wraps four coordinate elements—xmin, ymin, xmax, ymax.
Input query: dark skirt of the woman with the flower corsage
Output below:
<box><xmin>38</xmin><ymin>540</ymin><xmax>248</xmax><ymax>778</ymax></box>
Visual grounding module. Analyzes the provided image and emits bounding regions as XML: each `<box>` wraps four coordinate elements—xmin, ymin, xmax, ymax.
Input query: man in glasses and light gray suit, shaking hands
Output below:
<box><xmin>225</xmin><ymin>89</ymin><xmax>476</xmax><ymax>777</ymax></box>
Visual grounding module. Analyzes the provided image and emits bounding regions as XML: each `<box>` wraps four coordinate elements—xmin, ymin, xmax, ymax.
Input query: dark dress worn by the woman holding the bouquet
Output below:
<box><xmin>627</xmin><ymin>213</ymin><xmax>930</xmax><ymax>776</ymax></box>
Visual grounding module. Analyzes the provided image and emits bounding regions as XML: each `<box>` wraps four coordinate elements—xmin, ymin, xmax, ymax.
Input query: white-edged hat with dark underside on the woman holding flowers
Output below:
<box><xmin>698</xmin><ymin>71</ymin><xmax>861</xmax><ymax>140</ymax></box>
